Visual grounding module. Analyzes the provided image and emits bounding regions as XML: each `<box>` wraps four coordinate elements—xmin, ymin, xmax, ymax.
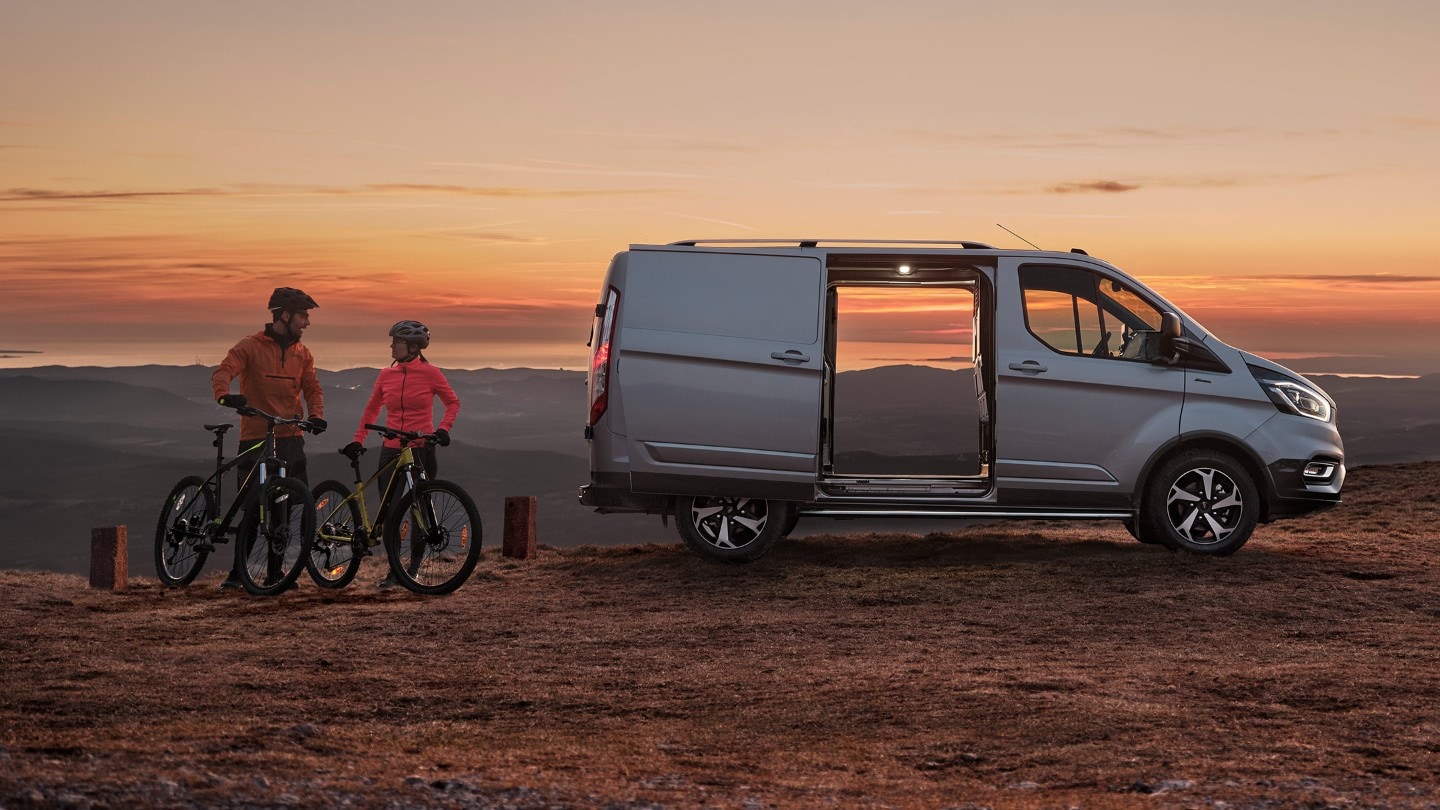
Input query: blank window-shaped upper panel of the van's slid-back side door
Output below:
<box><xmin>625</xmin><ymin>251</ymin><xmax>822</xmax><ymax>344</ymax></box>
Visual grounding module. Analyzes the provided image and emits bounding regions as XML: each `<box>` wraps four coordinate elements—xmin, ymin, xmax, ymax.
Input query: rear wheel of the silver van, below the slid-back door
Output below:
<box><xmin>675</xmin><ymin>496</ymin><xmax>795</xmax><ymax>562</ymax></box>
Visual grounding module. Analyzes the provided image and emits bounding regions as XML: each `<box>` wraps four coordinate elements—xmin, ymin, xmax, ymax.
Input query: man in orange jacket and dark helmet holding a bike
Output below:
<box><xmin>210</xmin><ymin>287</ymin><xmax>327</xmax><ymax>588</ymax></box>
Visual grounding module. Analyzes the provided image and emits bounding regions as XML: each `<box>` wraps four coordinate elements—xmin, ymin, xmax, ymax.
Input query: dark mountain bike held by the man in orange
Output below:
<box><xmin>156</xmin><ymin>405</ymin><xmax>315</xmax><ymax>597</ymax></box>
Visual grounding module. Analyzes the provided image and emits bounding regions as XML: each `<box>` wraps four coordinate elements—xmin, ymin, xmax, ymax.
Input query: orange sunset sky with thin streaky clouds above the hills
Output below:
<box><xmin>0</xmin><ymin>0</ymin><xmax>1440</xmax><ymax>373</ymax></box>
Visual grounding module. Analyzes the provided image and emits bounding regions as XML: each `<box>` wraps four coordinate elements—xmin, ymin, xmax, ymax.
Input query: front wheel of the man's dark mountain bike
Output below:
<box><xmin>235</xmin><ymin>479</ymin><xmax>315</xmax><ymax>597</ymax></box>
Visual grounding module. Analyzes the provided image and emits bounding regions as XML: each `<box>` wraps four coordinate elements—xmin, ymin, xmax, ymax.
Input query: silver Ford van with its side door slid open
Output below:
<box><xmin>580</xmin><ymin>239</ymin><xmax>1345</xmax><ymax>562</ymax></box>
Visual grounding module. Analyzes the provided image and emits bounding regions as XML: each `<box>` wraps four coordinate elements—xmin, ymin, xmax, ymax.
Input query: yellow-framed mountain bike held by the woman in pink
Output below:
<box><xmin>305</xmin><ymin>425</ymin><xmax>481</xmax><ymax>595</ymax></box>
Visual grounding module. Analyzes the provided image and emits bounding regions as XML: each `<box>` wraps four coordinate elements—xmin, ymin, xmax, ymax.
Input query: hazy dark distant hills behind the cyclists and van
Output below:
<box><xmin>0</xmin><ymin>366</ymin><xmax>1440</xmax><ymax>572</ymax></box>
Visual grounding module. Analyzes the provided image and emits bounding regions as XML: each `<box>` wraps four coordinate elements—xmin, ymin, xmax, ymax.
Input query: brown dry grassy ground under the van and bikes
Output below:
<box><xmin>0</xmin><ymin>464</ymin><xmax>1440</xmax><ymax>809</ymax></box>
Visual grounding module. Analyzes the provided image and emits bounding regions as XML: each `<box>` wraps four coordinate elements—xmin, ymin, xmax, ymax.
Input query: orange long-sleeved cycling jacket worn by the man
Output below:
<box><xmin>210</xmin><ymin>329</ymin><xmax>325</xmax><ymax>441</ymax></box>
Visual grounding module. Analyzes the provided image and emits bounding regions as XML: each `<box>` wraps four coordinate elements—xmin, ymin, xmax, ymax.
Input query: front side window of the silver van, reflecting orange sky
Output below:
<box><xmin>1020</xmin><ymin>265</ymin><xmax>1161</xmax><ymax>362</ymax></box>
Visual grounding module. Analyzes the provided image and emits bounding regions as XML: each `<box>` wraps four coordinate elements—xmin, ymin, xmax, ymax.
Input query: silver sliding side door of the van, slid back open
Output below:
<box><xmin>616</xmin><ymin>249</ymin><xmax>825</xmax><ymax>500</ymax></box>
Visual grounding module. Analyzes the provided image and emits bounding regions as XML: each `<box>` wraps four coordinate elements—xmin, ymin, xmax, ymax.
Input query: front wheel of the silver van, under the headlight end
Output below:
<box><xmin>1139</xmin><ymin>450</ymin><xmax>1260</xmax><ymax>556</ymax></box>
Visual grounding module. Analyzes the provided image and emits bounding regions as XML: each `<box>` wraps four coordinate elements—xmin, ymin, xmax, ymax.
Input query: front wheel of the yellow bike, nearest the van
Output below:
<box><xmin>384</xmin><ymin>481</ymin><xmax>484</xmax><ymax>595</ymax></box>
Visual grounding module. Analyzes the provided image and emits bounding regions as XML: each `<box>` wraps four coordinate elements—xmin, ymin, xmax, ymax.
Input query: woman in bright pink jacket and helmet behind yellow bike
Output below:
<box><xmin>341</xmin><ymin>320</ymin><xmax>459</xmax><ymax>480</ymax></box>
